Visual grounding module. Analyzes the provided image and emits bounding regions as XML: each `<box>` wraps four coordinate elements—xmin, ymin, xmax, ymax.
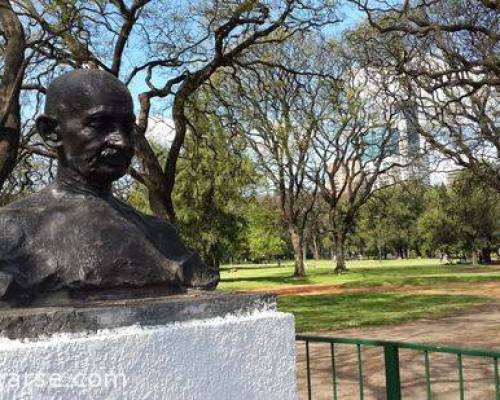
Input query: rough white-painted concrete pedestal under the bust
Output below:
<box><xmin>0</xmin><ymin>294</ymin><xmax>296</xmax><ymax>400</ymax></box>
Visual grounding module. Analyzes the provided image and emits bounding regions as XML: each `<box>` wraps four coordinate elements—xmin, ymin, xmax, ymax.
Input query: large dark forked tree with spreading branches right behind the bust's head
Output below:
<box><xmin>4</xmin><ymin>0</ymin><xmax>335</xmax><ymax>225</ymax></box>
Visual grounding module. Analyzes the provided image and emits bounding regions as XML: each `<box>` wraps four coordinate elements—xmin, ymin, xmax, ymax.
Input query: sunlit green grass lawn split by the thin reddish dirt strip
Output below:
<box><xmin>219</xmin><ymin>259</ymin><xmax>500</xmax><ymax>332</ymax></box>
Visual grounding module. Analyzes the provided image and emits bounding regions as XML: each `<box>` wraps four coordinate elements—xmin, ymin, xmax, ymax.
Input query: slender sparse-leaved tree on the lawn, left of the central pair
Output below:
<box><xmin>214</xmin><ymin>36</ymin><xmax>327</xmax><ymax>276</ymax></box>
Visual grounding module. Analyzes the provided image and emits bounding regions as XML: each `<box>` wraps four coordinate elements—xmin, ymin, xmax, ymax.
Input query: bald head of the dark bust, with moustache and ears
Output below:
<box><xmin>36</xmin><ymin>70</ymin><xmax>135</xmax><ymax>191</ymax></box>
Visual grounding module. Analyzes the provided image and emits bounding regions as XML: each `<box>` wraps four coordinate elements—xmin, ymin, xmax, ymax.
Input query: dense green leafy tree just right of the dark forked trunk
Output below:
<box><xmin>174</xmin><ymin>108</ymin><xmax>255</xmax><ymax>265</ymax></box>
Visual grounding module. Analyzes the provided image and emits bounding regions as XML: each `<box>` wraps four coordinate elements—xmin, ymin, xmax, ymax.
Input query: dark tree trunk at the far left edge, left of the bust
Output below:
<box><xmin>0</xmin><ymin>0</ymin><xmax>25</xmax><ymax>189</ymax></box>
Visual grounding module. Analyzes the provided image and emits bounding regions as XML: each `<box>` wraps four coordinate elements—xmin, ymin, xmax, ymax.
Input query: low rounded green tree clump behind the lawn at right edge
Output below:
<box><xmin>357</xmin><ymin>178</ymin><xmax>500</xmax><ymax>263</ymax></box>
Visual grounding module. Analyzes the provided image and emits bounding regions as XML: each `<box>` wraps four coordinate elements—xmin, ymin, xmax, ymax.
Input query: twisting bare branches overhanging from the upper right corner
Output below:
<box><xmin>352</xmin><ymin>0</ymin><xmax>500</xmax><ymax>190</ymax></box>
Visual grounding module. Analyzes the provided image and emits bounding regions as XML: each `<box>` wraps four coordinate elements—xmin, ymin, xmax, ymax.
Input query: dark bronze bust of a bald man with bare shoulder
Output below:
<box><xmin>0</xmin><ymin>70</ymin><xmax>219</xmax><ymax>302</ymax></box>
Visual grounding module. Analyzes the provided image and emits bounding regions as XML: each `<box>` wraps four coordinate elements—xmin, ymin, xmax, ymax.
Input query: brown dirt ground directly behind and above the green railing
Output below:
<box><xmin>297</xmin><ymin>304</ymin><xmax>500</xmax><ymax>400</ymax></box>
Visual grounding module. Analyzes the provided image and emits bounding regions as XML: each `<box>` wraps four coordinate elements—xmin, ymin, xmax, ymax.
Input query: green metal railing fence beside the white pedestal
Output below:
<box><xmin>296</xmin><ymin>335</ymin><xmax>500</xmax><ymax>400</ymax></box>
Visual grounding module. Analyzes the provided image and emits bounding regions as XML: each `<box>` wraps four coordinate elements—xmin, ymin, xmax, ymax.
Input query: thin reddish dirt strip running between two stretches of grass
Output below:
<box><xmin>250</xmin><ymin>282</ymin><xmax>500</xmax><ymax>299</ymax></box>
